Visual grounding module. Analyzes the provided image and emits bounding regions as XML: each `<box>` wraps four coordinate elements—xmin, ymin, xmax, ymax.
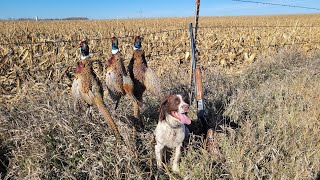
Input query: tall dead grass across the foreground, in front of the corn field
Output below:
<box><xmin>0</xmin><ymin>47</ymin><xmax>320</xmax><ymax>179</ymax></box>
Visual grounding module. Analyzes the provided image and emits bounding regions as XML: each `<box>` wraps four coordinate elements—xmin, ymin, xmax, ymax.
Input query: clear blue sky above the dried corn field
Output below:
<box><xmin>0</xmin><ymin>0</ymin><xmax>320</xmax><ymax>19</ymax></box>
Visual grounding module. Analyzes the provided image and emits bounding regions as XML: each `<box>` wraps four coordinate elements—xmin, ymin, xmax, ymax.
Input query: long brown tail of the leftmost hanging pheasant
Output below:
<box><xmin>94</xmin><ymin>97</ymin><xmax>121</xmax><ymax>141</ymax></box>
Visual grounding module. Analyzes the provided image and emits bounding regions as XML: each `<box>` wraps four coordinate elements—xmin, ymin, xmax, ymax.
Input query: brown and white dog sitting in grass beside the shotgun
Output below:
<box><xmin>155</xmin><ymin>94</ymin><xmax>191</xmax><ymax>172</ymax></box>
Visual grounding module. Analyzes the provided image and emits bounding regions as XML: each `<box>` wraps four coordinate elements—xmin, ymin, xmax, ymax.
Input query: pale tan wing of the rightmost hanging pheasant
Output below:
<box><xmin>144</xmin><ymin>68</ymin><xmax>162</xmax><ymax>96</ymax></box>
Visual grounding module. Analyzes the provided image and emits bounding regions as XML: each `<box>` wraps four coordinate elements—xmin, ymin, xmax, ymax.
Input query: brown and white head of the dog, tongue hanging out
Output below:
<box><xmin>159</xmin><ymin>94</ymin><xmax>191</xmax><ymax>124</ymax></box>
